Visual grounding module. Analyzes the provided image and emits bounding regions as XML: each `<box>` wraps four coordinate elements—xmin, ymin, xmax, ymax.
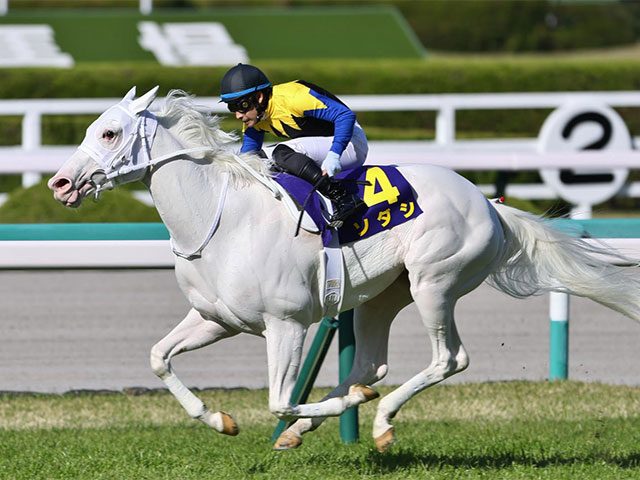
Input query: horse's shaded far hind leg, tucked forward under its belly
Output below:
<box><xmin>274</xmin><ymin>274</ymin><xmax>412</xmax><ymax>450</ymax></box>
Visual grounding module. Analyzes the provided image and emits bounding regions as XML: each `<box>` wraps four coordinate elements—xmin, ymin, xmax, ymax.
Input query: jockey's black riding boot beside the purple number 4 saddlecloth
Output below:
<box><xmin>272</xmin><ymin>145</ymin><xmax>367</xmax><ymax>228</ymax></box>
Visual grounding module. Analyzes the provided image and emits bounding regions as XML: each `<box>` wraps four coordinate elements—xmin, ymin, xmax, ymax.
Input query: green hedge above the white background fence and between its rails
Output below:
<box><xmin>0</xmin><ymin>59</ymin><xmax>640</xmax><ymax>145</ymax></box>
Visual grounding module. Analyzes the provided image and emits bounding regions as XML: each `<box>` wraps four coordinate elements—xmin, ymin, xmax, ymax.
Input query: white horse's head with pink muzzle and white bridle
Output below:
<box><xmin>47</xmin><ymin>87</ymin><xmax>158</xmax><ymax>208</ymax></box>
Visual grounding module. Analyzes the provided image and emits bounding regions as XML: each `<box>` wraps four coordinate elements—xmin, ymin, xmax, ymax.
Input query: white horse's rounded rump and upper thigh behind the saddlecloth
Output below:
<box><xmin>400</xmin><ymin>165</ymin><xmax>504</xmax><ymax>299</ymax></box>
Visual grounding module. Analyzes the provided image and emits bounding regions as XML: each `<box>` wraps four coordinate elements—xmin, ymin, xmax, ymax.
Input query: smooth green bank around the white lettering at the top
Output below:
<box><xmin>0</xmin><ymin>6</ymin><xmax>424</xmax><ymax>63</ymax></box>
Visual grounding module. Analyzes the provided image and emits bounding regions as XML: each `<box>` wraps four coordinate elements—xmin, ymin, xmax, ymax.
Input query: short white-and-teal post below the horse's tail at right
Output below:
<box><xmin>549</xmin><ymin>292</ymin><xmax>569</xmax><ymax>380</ymax></box>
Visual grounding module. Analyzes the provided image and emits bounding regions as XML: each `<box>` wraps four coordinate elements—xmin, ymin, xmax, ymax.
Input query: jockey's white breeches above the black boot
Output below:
<box><xmin>264</xmin><ymin>122</ymin><xmax>369</xmax><ymax>170</ymax></box>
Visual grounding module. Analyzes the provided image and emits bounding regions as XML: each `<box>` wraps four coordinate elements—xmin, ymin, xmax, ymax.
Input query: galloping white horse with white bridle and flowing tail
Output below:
<box><xmin>49</xmin><ymin>87</ymin><xmax>640</xmax><ymax>451</ymax></box>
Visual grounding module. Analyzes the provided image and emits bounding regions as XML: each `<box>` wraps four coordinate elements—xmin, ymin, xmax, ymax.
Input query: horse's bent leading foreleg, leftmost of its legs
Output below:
<box><xmin>151</xmin><ymin>309</ymin><xmax>238</xmax><ymax>435</ymax></box>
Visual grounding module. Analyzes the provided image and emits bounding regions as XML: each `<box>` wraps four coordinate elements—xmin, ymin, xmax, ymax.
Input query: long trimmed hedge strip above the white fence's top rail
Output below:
<box><xmin>0</xmin><ymin>58</ymin><xmax>640</xmax><ymax>98</ymax></box>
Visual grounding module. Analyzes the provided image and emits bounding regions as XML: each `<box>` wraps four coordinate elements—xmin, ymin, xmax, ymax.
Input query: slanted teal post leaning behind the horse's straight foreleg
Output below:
<box><xmin>271</xmin><ymin>318</ymin><xmax>338</xmax><ymax>442</ymax></box>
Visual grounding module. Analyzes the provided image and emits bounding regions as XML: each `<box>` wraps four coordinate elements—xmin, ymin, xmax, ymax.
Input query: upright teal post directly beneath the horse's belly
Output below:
<box><xmin>338</xmin><ymin>310</ymin><xmax>359</xmax><ymax>443</ymax></box>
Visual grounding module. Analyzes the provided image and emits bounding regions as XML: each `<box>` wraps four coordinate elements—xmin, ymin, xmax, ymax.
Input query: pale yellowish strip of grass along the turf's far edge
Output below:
<box><xmin>5</xmin><ymin>382</ymin><xmax>640</xmax><ymax>430</ymax></box>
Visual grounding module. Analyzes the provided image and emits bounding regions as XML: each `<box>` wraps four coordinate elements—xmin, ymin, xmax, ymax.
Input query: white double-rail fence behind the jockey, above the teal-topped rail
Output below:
<box><xmin>0</xmin><ymin>91</ymin><xmax>640</xmax><ymax>185</ymax></box>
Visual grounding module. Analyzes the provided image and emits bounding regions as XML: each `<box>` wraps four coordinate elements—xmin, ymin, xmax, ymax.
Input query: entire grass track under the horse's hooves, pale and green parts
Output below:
<box><xmin>0</xmin><ymin>381</ymin><xmax>640</xmax><ymax>480</ymax></box>
